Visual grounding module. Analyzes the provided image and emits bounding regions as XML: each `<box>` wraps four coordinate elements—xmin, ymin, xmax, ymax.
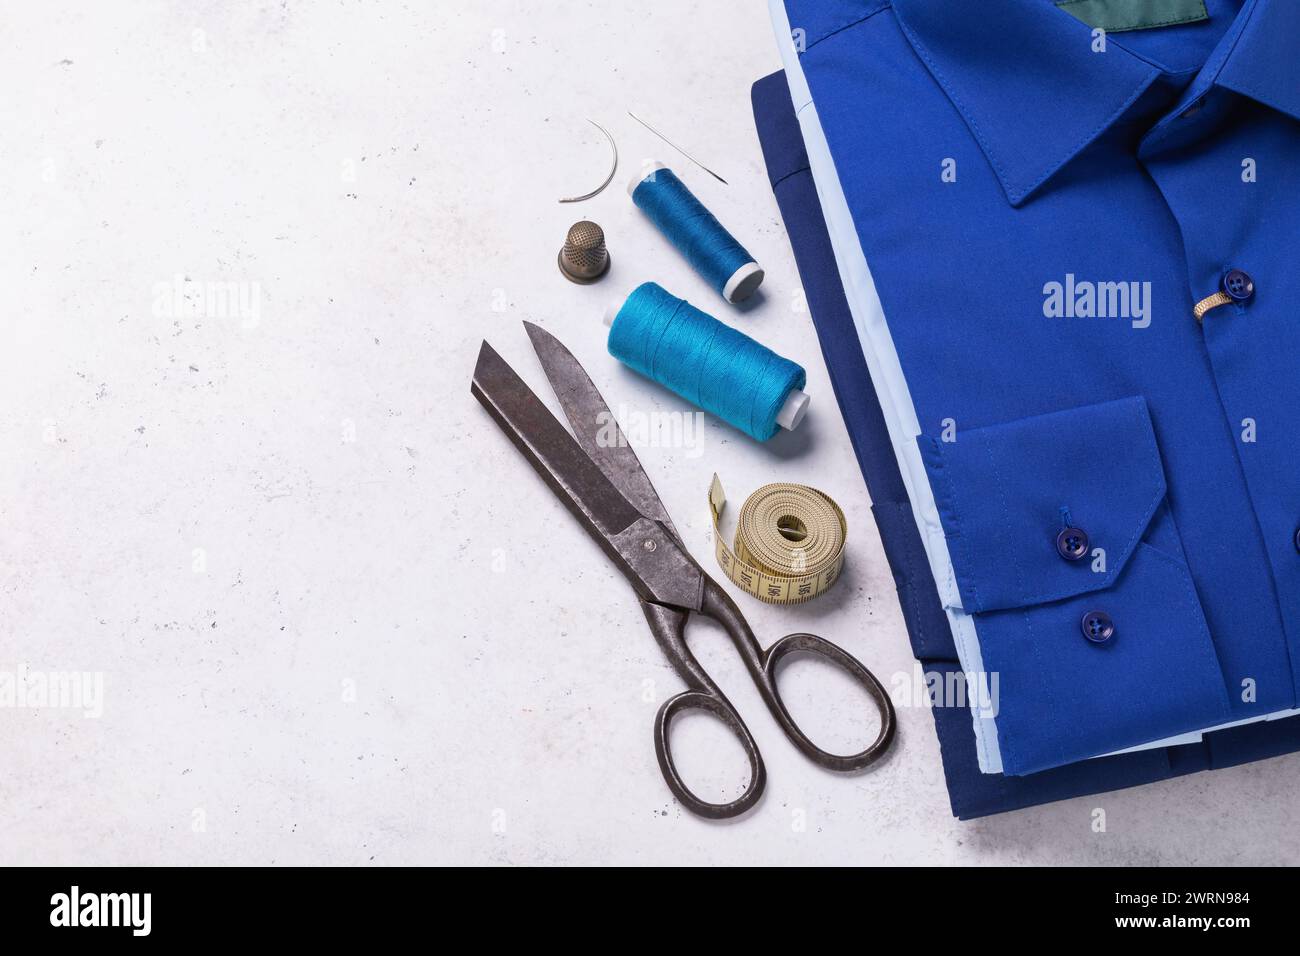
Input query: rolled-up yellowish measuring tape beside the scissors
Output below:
<box><xmin>709</xmin><ymin>475</ymin><xmax>849</xmax><ymax>604</ymax></box>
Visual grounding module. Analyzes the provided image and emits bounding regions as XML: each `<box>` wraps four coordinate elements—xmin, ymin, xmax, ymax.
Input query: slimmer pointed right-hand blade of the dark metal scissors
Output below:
<box><xmin>524</xmin><ymin>321</ymin><xmax>681</xmax><ymax>541</ymax></box>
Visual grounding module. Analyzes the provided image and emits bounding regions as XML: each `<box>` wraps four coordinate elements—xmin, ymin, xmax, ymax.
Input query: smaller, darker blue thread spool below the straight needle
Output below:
<box><xmin>628</xmin><ymin>163</ymin><xmax>763</xmax><ymax>303</ymax></box>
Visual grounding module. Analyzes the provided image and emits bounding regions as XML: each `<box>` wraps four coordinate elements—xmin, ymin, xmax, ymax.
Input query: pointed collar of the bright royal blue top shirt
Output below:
<box><xmin>893</xmin><ymin>0</ymin><xmax>1300</xmax><ymax>206</ymax></box>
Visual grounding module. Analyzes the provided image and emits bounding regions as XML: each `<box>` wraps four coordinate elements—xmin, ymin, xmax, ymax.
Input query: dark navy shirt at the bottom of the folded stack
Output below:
<box><xmin>753</xmin><ymin>65</ymin><xmax>1300</xmax><ymax>818</ymax></box>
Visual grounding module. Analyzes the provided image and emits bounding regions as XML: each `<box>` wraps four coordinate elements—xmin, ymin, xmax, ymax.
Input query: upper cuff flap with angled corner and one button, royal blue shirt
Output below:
<box><xmin>917</xmin><ymin>397</ymin><xmax>1165</xmax><ymax>613</ymax></box>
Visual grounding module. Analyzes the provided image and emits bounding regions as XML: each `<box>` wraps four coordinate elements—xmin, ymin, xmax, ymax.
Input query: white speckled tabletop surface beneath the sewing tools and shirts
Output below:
<box><xmin>0</xmin><ymin>1</ymin><xmax>1300</xmax><ymax>864</ymax></box>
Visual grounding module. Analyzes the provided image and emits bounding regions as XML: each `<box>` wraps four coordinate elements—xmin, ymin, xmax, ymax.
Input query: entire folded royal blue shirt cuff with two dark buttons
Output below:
<box><xmin>918</xmin><ymin>398</ymin><xmax>1230</xmax><ymax>774</ymax></box>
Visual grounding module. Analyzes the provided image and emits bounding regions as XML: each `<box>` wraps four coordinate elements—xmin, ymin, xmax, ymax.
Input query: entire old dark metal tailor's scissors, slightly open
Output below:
<box><xmin>471</xmin><ymin>321</ymin><xmax>894</xmax><ymax>819</ymax></box>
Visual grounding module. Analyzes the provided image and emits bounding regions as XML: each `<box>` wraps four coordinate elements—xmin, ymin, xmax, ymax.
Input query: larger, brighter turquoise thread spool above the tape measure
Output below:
<box><xmin>605</xmin><ymin>282</ymin><xmax>809</xmax><ymax>441</ymax></box>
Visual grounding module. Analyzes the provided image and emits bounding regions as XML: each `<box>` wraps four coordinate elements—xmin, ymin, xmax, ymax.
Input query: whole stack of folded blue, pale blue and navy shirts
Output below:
<box><xmin>753</xmin><ymin>0</ymin><xmax>1300</xmax><ymax>818</ymax></box>
